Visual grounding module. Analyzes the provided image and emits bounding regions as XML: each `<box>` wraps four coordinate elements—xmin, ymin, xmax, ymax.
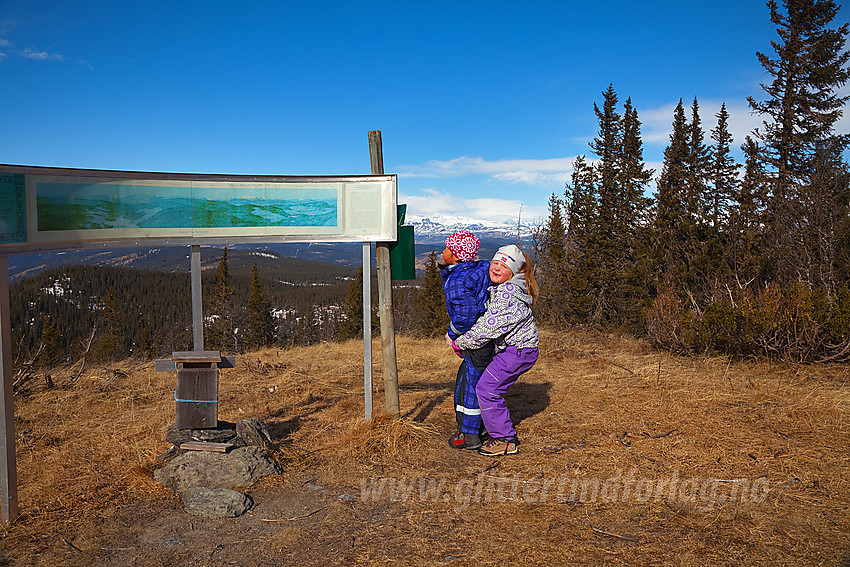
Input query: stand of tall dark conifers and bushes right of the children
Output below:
<box><xmin>534</xmin><ymin>0</ymin><xmax>850</xmax><ymax>361</ymax></box>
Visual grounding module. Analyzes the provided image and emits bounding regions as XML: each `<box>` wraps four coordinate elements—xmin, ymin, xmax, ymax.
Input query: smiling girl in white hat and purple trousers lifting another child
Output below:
<box><xmin>452</xmin><ymin>245</ymin><xmax>539</xmax><ymax>457</ymax></box>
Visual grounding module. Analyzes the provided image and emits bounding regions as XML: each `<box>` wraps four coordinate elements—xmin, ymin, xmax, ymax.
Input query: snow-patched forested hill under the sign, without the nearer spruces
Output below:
<box><xmin>10</xmin><ymin>250</ymin><xmax>357</xmax><ymax>365</ymax></box>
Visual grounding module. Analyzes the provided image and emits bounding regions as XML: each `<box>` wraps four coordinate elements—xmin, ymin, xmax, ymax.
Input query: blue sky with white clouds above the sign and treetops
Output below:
<box><xmin>0</xmin><ymin>0</ymin><xmax>850</xmax><ymax>226</ymax></box>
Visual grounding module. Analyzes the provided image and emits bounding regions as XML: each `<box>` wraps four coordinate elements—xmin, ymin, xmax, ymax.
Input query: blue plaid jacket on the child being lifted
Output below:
<box><xmin>440</xmin><ymin>260</ymin><xmax>492</xmax><ymax>339</ymax></box>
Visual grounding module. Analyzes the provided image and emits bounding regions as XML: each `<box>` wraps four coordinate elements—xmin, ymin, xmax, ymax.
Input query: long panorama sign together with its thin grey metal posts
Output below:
<box><xmin>0</xmin><ymin>164</ymin><xmax>398</xmax><ymax>524</ymax></box>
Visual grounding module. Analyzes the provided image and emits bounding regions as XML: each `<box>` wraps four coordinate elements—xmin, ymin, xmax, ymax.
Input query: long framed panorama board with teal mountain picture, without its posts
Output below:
<box><xmin>0</xmin><ymin>165</ymin><xmax>397</xmax><ymax>253</ymax></box>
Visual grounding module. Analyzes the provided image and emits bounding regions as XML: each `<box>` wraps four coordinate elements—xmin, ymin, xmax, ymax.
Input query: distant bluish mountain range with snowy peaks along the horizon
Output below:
<box><xmin>9</xmin><ymin>216</ymin><xmax>533</xmax><ymax>282</ymax></box>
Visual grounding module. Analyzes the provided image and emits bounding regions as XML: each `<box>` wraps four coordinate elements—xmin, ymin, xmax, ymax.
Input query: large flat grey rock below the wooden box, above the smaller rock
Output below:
<box><xmin>153</xmin><ymin>447</ymin><xmax>280</xmax><ymax>493</ymax></box>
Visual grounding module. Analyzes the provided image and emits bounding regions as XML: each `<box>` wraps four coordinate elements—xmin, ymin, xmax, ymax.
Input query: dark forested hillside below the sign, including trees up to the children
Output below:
<box><xmin>10</xmin><ymin>244</ymin><xmax>447</xmax><ymax>367</ymax></box>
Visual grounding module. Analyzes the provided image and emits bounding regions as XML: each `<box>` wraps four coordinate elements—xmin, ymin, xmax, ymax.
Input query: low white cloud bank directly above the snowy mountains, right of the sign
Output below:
<box><xmin>398</xmin><ymin>188</ymin><xmax>547</xmax><ymax>226</ymax></box>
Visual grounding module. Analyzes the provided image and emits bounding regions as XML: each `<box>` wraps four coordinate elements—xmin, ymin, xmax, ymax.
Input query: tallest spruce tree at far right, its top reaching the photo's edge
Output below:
<box><xmin>748</xmin><ymin>0</ymin><xmax>850</xmax><ymax>285</ymax></box>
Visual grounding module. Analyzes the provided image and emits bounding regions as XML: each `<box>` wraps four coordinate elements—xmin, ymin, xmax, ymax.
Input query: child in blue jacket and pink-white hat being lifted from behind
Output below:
<box><xmin>439</xmin><ymin>230</ymin><xmax>494</xmax><ymax>449</ymax></box>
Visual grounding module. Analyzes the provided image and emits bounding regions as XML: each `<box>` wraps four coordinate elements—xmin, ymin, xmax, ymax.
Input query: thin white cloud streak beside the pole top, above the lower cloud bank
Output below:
<box><xmin>398</xmin><ymin>156</ymin><xmax>575</xmax><ymax>185</ymax></box>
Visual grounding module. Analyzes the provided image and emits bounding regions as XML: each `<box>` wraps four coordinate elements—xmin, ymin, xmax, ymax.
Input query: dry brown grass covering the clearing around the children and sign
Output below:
<box><xmin>0</xmin><ymin>333</ymin><xmax>850</xmax><ymax>565</ymax></box>
